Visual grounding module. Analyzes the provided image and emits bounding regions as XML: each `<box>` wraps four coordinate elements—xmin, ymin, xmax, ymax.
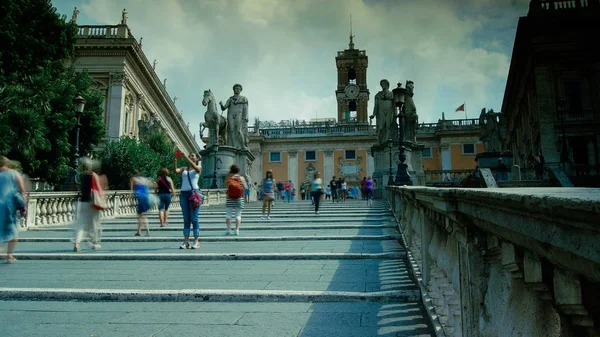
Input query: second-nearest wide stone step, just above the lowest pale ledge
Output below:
<box><xmin>0</xmin><ymin>254</ymin><xmax>418</xmax><ymax>292</ymax></box>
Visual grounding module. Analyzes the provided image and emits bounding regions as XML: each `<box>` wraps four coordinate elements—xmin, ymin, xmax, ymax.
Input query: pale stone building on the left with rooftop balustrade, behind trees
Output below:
<box><xmin>70</xmin><ymin>22</ymin><xmax>200</xmax><ymax>153</ymax></box>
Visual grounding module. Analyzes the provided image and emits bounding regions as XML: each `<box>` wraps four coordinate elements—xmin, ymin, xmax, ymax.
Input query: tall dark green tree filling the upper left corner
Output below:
<box><xmin>0</xmin><ymin>0</ymin><xmax>105</xmax><ymax>186</ymax></box>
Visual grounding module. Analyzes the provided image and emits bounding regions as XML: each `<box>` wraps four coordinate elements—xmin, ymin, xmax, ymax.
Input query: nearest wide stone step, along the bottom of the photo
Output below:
<box><xmin>0</xmin><ymin>301</ymin><xmax>432</xmax><ymax>337</ymax></box>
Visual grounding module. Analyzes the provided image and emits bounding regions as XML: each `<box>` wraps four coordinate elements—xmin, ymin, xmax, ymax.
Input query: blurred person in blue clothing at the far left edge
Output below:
<box><xmin>0</xmin><ymin>156</ymin><xmax>27</xmax><ymax>263</ymax></box>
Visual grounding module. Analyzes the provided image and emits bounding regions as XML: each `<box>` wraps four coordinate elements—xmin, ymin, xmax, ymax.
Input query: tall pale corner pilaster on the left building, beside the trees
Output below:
<box><xmin>106</xmin><ymin>71</ymin><xmax>127</xmax><ymax>140</ymax></box>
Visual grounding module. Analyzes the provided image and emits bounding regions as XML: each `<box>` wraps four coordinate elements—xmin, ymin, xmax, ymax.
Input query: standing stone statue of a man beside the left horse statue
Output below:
<box><xmin>219</xmin><ymin>84</ymin><xmax>248</xmax><ymax>149</ymax></box>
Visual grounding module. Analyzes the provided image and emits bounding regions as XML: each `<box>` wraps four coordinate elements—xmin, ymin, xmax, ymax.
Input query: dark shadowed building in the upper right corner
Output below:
<box><xmin>502</xmin><ymin>0</ymin><xmax>600</xmax><ymax>186</ymax></box>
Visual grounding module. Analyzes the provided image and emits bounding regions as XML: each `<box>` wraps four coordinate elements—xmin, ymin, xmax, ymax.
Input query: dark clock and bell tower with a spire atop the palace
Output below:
<box><xmin>335</xmin><ymin>16</ymin><xmax>369</xmax><ymax>122</ymax></box>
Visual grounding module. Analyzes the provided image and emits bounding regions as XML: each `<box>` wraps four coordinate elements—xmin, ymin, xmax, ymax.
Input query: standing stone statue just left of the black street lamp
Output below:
<box><xmin>369</xmin><ymin>79</ymin><xmax>398</xmax><ymax>144</ymax></box>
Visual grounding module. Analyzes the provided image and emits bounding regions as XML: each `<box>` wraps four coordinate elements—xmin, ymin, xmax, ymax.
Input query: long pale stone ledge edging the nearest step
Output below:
<box><xmin>0</xmin><ymin>287</ymin><xmax>420</xmax><ymax>303</ymax></box>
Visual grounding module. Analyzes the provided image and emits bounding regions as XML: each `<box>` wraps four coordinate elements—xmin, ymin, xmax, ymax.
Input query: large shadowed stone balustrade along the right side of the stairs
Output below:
<box><xmin>386</xmin><ymin>186</ymin><xmax>600</xmax><ymax>337</ymax></box>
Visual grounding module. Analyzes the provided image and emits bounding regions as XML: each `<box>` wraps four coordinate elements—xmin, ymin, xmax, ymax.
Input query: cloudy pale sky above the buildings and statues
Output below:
<box><xmin>52</xmin><ymin>0</ymin><xmax>529</xmax><ymax>133</ymax></box>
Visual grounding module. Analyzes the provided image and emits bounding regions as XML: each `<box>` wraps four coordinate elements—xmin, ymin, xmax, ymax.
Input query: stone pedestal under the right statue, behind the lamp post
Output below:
<box><xmin>371</xmin><ymin>141</ymin><xmax>425</xmax><ymax>199</ymax></box>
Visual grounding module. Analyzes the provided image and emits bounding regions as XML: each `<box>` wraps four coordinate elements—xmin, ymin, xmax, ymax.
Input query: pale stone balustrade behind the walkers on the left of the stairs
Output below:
<box><xmin>19</xmin><ymin>189</ymin><xmax>226</xmax><ymax>228</ymax></box>
